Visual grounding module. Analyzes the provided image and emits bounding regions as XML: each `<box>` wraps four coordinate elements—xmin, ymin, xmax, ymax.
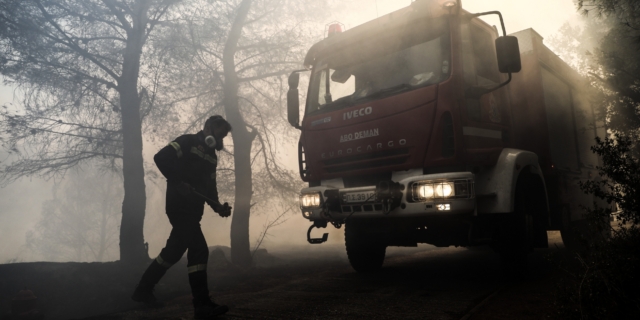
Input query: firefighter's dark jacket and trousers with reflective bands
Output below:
<box><xmin>140</xmin><ymin>131</ymin><xmax>218</xmax><ymax>301</ymax></box>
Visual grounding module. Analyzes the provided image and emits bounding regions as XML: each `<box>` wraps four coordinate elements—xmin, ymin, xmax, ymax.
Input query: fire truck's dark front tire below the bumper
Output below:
<box><xmin>344</xmin><ymin>221</ymin><xmax>387</xmax><ymax>273</ymax></box>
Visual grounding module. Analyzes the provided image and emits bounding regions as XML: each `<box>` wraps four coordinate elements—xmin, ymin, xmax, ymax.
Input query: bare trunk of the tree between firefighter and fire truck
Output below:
<box><xmin>222</xmin><ymin>0</ymin><xmax>256</xmax><ymax>267</ymax></box>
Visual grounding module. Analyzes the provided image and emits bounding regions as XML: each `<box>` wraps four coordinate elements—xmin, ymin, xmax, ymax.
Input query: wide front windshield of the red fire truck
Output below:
<box><xmin>306</xmin><ymin>19</ymin><xmax>450</xmax><ymax>113</ymax></box>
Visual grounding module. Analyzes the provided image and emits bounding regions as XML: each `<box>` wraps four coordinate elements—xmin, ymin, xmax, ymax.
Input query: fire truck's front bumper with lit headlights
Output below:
<box><xmin>301</xmin><ymin>172</ymin><xmax>476</xmax><ymax>221</ymax></box>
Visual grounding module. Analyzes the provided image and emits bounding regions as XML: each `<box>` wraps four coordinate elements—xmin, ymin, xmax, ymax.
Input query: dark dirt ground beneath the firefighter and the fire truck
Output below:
<box><xmin>0</xmin><ymin>233</ymin><xmax>564</xmax><ymax>320</ymax></box>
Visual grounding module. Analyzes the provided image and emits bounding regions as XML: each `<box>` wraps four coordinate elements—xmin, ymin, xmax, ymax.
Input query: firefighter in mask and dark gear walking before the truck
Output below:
<box><xmin>131</xmin><ymin>115</ymin><xmax>231</xmax><ymax>319</ymax></box>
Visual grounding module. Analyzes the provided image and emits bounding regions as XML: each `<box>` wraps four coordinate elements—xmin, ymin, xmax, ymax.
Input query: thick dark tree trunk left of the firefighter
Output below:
<box><xmin>118</xmin><ymin>1</ymin><xmax>149</xmax><ymax>263</ymax></box>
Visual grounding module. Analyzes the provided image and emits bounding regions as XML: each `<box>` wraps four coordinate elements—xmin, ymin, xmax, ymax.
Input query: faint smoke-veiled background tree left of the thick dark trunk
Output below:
<box><xmin>27</xmin><ymin>167</ymin><xmax>122</xmax><ymax>261</ymax></box>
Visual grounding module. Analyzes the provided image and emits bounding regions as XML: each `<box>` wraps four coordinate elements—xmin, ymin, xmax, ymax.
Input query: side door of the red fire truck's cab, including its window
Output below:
<box><xmin>461</xmin><ymin>19</ymin><xmax>509</xmax><ymax>164</ymax></box>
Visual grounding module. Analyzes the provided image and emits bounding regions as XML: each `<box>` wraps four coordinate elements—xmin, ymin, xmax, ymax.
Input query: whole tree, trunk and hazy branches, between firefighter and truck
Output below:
<box><xmin>158</xmin><ymin>0</ymin><xmax>327</xmax><ymax>266</ymax></box>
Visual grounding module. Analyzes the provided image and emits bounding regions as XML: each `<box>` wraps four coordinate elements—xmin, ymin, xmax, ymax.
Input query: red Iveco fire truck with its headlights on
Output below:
<box><xmin>287</xmin><ymin>0</ymin><xmax>604</xmax><ymax>272</ymax></box>
